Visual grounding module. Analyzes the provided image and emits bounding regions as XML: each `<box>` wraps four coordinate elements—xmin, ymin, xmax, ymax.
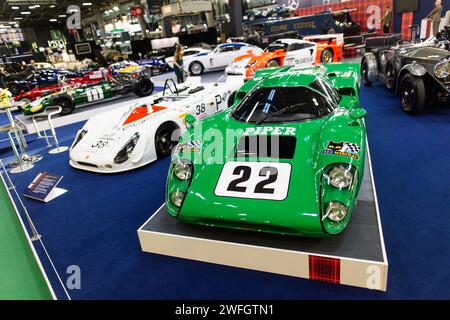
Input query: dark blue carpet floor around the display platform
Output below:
<box><xmin>0</xmin><ymin>86</ymin><xmax>450</xmax><ymax>299</ymax></box>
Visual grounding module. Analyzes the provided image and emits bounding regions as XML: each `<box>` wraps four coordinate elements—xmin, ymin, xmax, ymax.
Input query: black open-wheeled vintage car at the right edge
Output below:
<box><xmin>361</xmin><ymin>28</ymin><xmax>450</xmax><ymax>114</ymax></box>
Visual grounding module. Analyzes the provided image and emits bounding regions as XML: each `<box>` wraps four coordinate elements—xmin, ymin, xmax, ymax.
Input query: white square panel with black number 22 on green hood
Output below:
<box><xmin>214</xmin><ymin>162</ymin><xmax>291</xmax><ymax>200</ymax></box>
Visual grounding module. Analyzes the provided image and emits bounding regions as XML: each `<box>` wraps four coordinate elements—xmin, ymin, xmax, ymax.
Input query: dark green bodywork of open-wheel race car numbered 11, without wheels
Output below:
<box><xmin>22</xmin><ymin>81</ymin><xmax>114</xmax><ymax>116</ymax></box>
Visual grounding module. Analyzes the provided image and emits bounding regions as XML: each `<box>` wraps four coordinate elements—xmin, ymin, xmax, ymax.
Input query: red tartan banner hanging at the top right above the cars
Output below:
<box><xmin>295</xmin><ymin>0</ymin><xmax>394</xmax><ymax>32</ymax></box>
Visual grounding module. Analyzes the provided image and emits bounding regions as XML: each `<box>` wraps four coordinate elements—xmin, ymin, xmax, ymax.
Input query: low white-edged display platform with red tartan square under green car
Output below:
<box><xmin>137</xmin><ymin>146</ymin><xmax>388</xmax><ymax>291</ymax></box>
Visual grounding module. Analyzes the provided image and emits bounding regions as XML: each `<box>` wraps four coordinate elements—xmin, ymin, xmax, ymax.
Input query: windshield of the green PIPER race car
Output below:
<box><xmin>232</xmin><ymin>87</ymin><xmax>335</xmax><ymax>124</ymax></box>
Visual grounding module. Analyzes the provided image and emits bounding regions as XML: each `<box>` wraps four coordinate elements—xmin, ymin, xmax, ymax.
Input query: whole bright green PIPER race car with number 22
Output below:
<box><xmin>166</xmin><ymin>64</ymin><xmax>367</xmax><ymax>237</ymax></box>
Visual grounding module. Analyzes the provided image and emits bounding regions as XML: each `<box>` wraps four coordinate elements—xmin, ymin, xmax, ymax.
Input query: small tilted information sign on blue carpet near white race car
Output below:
<box><xmin>23</xmin><ymin>172</ymin><xmax>67</xmax><ymax>202</ymax></box>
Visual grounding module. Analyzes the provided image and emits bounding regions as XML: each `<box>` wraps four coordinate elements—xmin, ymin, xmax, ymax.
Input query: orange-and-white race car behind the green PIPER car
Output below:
<box><xmin>225</xmin><ymin>34</ymin><xmax>344</xmax><ymax>79</ymax></box>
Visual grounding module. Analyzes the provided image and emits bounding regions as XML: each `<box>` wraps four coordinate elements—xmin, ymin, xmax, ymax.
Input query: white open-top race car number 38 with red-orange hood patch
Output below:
<box><xmin>70</xmin><ymin>77</ymin><xmax>244</xmax><ymax>173</ymax></box>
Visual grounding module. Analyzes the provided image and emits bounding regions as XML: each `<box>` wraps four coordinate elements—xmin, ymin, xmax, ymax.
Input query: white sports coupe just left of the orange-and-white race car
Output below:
<box><xmin>184</xmin><ymin>42</ymin><xmax>263</xmax><ymax>76</ymax></box>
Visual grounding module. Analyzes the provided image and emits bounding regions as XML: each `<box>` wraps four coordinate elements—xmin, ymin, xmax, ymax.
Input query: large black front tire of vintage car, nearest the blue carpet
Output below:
<box><xmin>399</xmin><ymin>73</ymin><xmax>425</xmax><ymax>115</ymax></box>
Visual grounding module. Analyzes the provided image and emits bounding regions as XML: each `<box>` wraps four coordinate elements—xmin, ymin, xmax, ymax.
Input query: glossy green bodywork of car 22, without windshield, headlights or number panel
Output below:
<box><xmin>166</xmin><ymin>64</ymin><xmax>366</xmax><ymax>237</ymax></box>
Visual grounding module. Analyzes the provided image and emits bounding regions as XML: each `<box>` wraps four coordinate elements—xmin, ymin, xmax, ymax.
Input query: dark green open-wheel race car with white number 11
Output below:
<box><xmin>22</xmin><ymin>75</ymin><xmax>154</xmax><ymax>116</ymax></box>
